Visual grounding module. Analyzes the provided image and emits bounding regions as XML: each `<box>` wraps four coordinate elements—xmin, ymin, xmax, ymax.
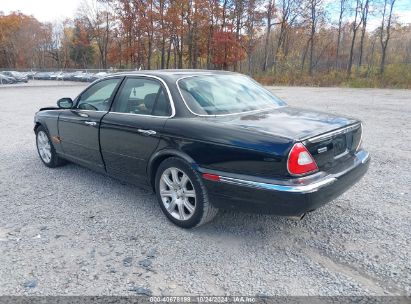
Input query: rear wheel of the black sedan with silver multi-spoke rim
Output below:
<box><xmin>155</xmin><ymin>157</ymin><xmax>218</xmax><ymax>228</ymax></box>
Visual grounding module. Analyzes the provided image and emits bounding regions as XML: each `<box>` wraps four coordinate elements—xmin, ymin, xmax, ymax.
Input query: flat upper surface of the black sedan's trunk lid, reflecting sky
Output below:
<box><xmin>204</xmin><ymin>106</ymin><xmax>358</xmax><ymax>140</ymax></box>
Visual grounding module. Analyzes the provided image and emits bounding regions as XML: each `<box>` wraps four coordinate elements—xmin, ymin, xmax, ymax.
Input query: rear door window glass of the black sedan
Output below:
<box><xmin>111</xmin><ymin>78</ymin><xmax>171</xmax><ymax>116</ymax></box>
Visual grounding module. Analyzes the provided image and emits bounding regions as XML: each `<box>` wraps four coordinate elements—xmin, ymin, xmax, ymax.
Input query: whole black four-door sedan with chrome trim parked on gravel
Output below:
<box><xmin>34</xmin><ymin>70</ymin><xmax>370</xmax><ymax>228</ymax></box>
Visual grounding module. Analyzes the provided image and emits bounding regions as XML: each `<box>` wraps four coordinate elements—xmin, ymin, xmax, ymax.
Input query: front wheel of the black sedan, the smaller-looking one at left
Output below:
<box><xmin>36</xmin><ymin>126</ymin><xmax>66</xmax><ymax>168</ymax></box>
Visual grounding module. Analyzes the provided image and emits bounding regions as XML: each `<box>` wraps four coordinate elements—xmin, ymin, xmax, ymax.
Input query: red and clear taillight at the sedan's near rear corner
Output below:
<box><xmin>287</xmin><ymin>143</ymin><xmax>318</xmax><ymax>175</ymax></box>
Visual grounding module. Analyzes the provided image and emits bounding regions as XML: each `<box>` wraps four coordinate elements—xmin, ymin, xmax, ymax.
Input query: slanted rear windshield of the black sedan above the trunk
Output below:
<box><xmin>177</xmin><ymin>75</ymin><xmax>285</xmax><ymax>115</ymax></box>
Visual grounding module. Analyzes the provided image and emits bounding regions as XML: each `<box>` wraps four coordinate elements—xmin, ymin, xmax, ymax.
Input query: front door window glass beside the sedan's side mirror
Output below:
<box><xmin>77</xmin><ymin>78</ymin><xmax>121</xmax><ymax>111</ymax></box>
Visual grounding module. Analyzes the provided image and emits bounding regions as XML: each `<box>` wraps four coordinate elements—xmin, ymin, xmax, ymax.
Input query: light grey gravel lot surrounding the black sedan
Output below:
<box><xmin>0</xmin><ymin>81</ymin><xmax>411</xmax><ymax>296</ymax></box>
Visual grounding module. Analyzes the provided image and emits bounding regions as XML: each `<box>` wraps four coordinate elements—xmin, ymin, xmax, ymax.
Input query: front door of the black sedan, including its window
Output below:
<box><xmin>58</xmin><ymin>77</ymin><xmax>122</xmax><ymax>172</ymax></box>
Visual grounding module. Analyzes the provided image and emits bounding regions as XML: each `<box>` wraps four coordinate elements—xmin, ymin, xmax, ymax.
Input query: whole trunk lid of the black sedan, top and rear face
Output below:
<box><xmin>206</xmin><ymin>107</ymin><xmax>361</xmax><ymax>170</ymax></box>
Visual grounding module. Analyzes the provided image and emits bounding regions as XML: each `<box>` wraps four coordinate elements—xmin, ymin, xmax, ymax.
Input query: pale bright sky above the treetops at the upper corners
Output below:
<box><xmin>0</xmin><ymin>0</ymin><xmax>411</xmax><ymax>30</ymax></box>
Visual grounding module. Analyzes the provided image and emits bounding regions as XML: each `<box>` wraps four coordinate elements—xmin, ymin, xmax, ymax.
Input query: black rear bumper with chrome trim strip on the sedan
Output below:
<box><xmin>204</xmin><ymin>150</ymin><xmax>370</xmax><ymax>216</ymax></box>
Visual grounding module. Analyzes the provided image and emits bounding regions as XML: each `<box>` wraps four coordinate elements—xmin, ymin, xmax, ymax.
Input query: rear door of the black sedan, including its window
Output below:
<box><xmin>100</xmin><ymin>76</ymin><xmax>173</xmax><ymax>184</ymax></box>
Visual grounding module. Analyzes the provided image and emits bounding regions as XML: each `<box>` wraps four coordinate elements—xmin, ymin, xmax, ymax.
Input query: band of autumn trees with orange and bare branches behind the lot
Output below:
<box><xmin>0</xmin><ymin>0</ymin><xmax>411</xmax><ymax>88</ymax></box>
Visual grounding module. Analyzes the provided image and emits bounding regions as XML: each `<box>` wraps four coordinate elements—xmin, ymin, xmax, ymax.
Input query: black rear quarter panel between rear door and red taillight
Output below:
<box><xmin>163</xmin><ymin>118</ymin><xmax>292</xmax><ymax>178</ymax></box>
